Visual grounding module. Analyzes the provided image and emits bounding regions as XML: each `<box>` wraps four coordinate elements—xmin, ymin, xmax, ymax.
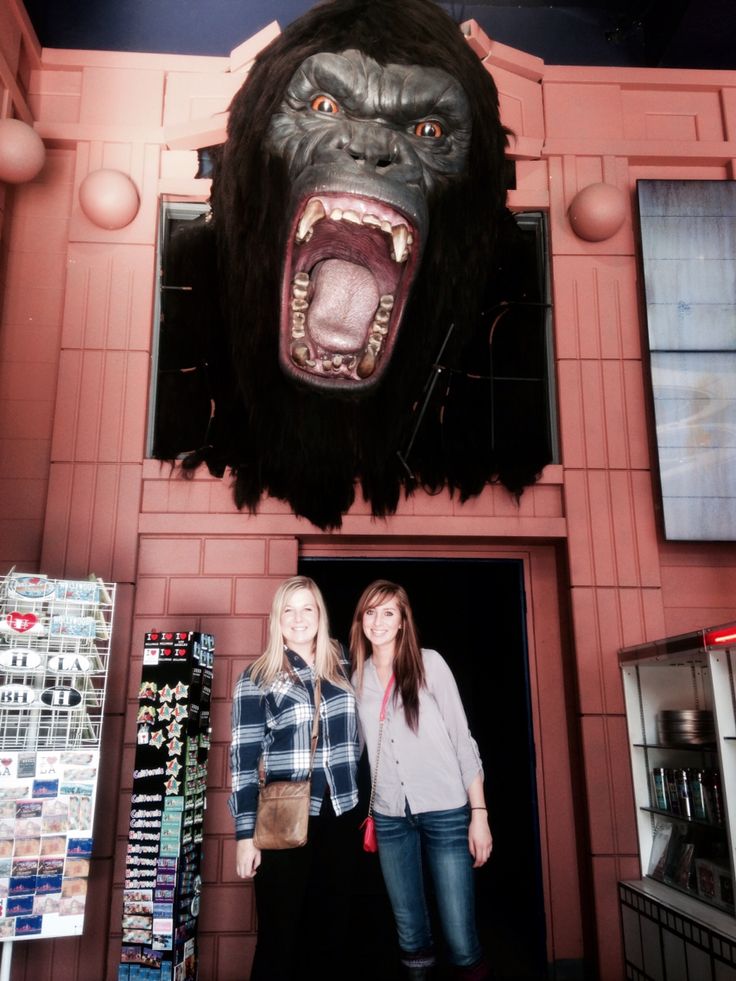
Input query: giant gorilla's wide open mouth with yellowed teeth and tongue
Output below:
<box><xmin>279</xmin><ymin>193</ymin><xmax>419</xmax><ymax>391</ymax></box>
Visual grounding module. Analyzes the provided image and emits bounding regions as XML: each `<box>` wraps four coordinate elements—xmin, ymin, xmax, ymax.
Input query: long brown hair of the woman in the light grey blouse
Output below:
<box><xmin>350</xmin><ymin>579</ymin><xmax>425</xmax><ymax>732</ymax></box>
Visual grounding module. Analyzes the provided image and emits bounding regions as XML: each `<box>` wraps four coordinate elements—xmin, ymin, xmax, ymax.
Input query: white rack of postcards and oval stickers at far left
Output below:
<box><xmin>0</xmin><ymin>572</ymin><xmax>115</xmax><ymax>952</ymax></box>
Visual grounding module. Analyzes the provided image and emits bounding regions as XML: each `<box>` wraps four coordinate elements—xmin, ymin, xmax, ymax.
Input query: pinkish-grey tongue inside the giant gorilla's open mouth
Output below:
<box><xmin>308</xmin><ymin>259</ymin><xmax>380</xmax><ymax>354</ymax></box>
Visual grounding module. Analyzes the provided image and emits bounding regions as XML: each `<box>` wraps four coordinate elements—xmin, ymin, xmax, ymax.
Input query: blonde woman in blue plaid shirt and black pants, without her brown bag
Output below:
<box><xmin>229</xmin><ymin>576</ymin><xmax>359</xmax><ymax>981</ymax></box>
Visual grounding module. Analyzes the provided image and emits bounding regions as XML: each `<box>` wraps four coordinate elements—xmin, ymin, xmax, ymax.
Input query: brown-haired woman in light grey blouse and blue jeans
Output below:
<box><xmin>350</xmin><ymin>579</ymin><xmax>492</xmax><ymax>981</ymax></box>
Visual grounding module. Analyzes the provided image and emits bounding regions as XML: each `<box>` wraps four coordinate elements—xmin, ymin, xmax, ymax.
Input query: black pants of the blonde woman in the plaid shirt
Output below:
<box><xmin>250</xmin><ymin>798</ymin><xmax>359</xmax><ymax>981</ymax></box>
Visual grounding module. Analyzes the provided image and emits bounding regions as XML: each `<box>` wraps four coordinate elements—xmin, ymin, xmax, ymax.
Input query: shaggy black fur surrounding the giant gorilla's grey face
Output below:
<box><xmin>160</xmin><ymin>0</ymin><xmax>550</xmax><ymax>529</ymax></box>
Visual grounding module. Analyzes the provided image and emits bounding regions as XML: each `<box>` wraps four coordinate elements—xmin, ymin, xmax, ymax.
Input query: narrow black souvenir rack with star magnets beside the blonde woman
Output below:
<box><xmin>118</xmin><ymin>631</ymin><xmax>214</xmax><ymax>981</ymax></box>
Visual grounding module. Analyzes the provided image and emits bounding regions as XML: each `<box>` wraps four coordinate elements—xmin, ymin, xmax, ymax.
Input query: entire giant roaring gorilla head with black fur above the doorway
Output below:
<box><xmin>160</xmin><ymin>0</ymin><xmax>548</xmax><ymax>528</ymax></box>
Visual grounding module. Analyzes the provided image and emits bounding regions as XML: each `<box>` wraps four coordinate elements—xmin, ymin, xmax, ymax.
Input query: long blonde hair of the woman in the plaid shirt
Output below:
<box><xmin>250</xmin><ymin>576</ymin><xmax>350</xmax><ymax>689</ymax></box>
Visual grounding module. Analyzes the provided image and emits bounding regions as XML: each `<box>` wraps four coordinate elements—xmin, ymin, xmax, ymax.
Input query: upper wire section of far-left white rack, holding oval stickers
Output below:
<box><xmin>0</xmin><ymin>572</ymin><xmax>115</xmax><ymax>751</ymax></box>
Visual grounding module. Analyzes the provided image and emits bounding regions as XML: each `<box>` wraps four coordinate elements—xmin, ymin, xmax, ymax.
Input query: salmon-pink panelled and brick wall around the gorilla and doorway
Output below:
<box><xmin>0</xmin><ymin>0</ymin><xmax>736</xmax><ymax>981</ymax></box>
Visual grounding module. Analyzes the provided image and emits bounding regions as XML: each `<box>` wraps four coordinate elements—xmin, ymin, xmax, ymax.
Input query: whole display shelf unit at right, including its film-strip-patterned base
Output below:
<box><xmin>619</xmin><ymin>623</ymin><xmax>736</xmax><ymax>979</ymax></box>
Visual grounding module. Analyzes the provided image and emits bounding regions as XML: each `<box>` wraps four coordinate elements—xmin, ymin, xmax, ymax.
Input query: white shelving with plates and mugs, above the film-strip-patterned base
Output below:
<box><xmin>619</xmin><ymin>623</ymin><xmax>736</xmax><ymax>916</ymax></box>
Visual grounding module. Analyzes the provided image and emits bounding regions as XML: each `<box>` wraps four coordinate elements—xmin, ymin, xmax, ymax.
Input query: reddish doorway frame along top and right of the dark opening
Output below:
<box><xmin>299</xmin><ymin>536</ymin><xmax>584</xmax><ymax>964</ymax></box>
